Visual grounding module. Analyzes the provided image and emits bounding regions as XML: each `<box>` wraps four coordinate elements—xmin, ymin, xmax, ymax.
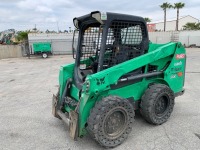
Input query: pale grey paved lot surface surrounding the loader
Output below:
<box><xmin>0</xmin><ymin>48</ymin><xmax>200</xmax><ymax>150</ymax></box>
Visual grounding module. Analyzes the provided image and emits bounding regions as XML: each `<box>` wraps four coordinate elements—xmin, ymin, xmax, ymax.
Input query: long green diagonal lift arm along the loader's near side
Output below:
<box><xmin>86</xmin><ymin>43</ymin><xmax>176</xmax><ymax>92</ymax></box>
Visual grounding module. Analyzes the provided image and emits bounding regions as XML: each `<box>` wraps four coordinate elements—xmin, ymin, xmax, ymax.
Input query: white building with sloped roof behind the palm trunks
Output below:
<box><xmin>154</xmin><ymin>15</ymin><xmax>199</xmax><ymax>31</ymax></box>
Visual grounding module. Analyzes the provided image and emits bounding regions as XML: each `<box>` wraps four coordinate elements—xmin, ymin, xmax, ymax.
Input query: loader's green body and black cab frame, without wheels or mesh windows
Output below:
<box><xmin>53</xmin><ymin>12</ymin><xmax>186</xmax><ymax>139</ymax></box>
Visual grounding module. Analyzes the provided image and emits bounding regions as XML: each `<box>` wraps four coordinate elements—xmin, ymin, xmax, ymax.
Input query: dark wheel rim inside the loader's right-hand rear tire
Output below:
<box><xmin>155</xmin><ymin>95</ymin><xmax>169</xmax><ymax>116</ymax></box>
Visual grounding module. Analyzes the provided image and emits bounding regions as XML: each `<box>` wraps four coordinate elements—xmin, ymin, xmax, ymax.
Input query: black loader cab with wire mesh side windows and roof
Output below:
<box><xmin>73</xmin><ymin>12</ymin><xmax>149</xmax><ymax>88</ymax></box>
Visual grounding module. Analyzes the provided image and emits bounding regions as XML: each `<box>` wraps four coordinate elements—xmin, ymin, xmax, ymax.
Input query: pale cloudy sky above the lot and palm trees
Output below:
<box><xmin>0</xmin><ymin>0</ymin><xmax>200</xmax><ymax>31</ymax></box>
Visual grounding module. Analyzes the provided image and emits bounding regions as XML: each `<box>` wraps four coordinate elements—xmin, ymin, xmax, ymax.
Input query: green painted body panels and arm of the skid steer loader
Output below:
<box><xmin>56</xmin><ymin>43</ymin><xmax>185</xmax><ymax>136</ymax></box>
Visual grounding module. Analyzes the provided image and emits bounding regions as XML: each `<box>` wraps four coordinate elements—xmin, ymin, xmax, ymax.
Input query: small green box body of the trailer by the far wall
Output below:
<box><xmin>33</xmin><ymin>42</ymin><xmax>51</xmax><ymax>53</ymax></box>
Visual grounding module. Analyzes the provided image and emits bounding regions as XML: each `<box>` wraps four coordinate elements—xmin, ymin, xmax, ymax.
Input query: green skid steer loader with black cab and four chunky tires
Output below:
<box><xmin>52</xmin><ymin>11</ymin><xmax>186</xmax><ymax>147</ymax></box>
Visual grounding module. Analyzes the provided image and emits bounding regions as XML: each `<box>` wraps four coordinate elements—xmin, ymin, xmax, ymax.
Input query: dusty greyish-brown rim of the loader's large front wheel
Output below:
<box><xmin>103</xmin><ymin>108</ymin><xmax>127</xmax><ymax>139</ymax></box>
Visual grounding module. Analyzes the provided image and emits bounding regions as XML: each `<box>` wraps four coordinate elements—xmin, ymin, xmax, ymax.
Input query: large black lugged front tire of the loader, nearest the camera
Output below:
<box><xmin>87</xmin><ymin>96</ymin><xmax>135</xmax><ymax>148</ymax></box>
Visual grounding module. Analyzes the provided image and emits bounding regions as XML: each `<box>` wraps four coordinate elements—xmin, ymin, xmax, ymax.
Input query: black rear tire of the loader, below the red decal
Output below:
<box><xmin>140</xmin><ymin>84</ymin><xmax>175</xmax><ymax>125</ymax></box>
